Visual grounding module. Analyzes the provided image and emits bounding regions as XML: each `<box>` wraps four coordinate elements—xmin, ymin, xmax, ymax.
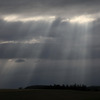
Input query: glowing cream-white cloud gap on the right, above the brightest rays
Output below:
<box><xmin>63</xmin><ymin>15</ymin><xmax>96</xmax><ymax>24</ymax></box>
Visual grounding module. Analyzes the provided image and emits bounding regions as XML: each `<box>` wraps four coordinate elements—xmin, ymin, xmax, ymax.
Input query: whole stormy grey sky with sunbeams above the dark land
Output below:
<box><xmin>0</xmin><ymin>0</ymin><xmax>100</xmax><ymax>88</ymax></box>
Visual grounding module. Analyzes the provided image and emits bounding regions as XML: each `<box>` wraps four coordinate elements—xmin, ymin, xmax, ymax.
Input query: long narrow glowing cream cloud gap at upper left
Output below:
<box><xmin>3</xmin><ymin>15</ymin><xmax>56</xmax><ymax>22</ymax></box>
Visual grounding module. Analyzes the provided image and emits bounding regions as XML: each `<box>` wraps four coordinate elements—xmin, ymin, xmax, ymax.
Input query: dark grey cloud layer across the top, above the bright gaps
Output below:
<box><xmin>0</xmin><ymin>0</ymin><xmax>100</xmax><ymax>16</ymax></box>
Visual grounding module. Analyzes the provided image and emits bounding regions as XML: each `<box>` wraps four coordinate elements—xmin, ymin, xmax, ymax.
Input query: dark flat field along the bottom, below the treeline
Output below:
<box><xmin>0</xmin><ymin>89</ymin><xmax>100</xmax><ymax>100</ymax></box>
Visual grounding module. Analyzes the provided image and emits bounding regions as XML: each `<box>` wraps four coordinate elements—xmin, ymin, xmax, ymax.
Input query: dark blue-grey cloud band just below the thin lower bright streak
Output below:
<box><xmin>0</xmin><ymin>43</ymin><xmax>100</xmax><ymax>61</ymax></box>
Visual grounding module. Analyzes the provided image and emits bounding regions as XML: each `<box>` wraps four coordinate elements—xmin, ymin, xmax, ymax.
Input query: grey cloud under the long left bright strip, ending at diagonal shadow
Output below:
<box><xmin>0</xmin><ymin>20</ymin><xmax>49</xmax><ymax>41</ymax></box>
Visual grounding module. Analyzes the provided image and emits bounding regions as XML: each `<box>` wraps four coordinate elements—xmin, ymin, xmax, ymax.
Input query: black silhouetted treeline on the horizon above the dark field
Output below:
<box><xmin>25</xmin><ymin>84</ymin><xmax>100</xmax><ymax>91</ymax></box>
